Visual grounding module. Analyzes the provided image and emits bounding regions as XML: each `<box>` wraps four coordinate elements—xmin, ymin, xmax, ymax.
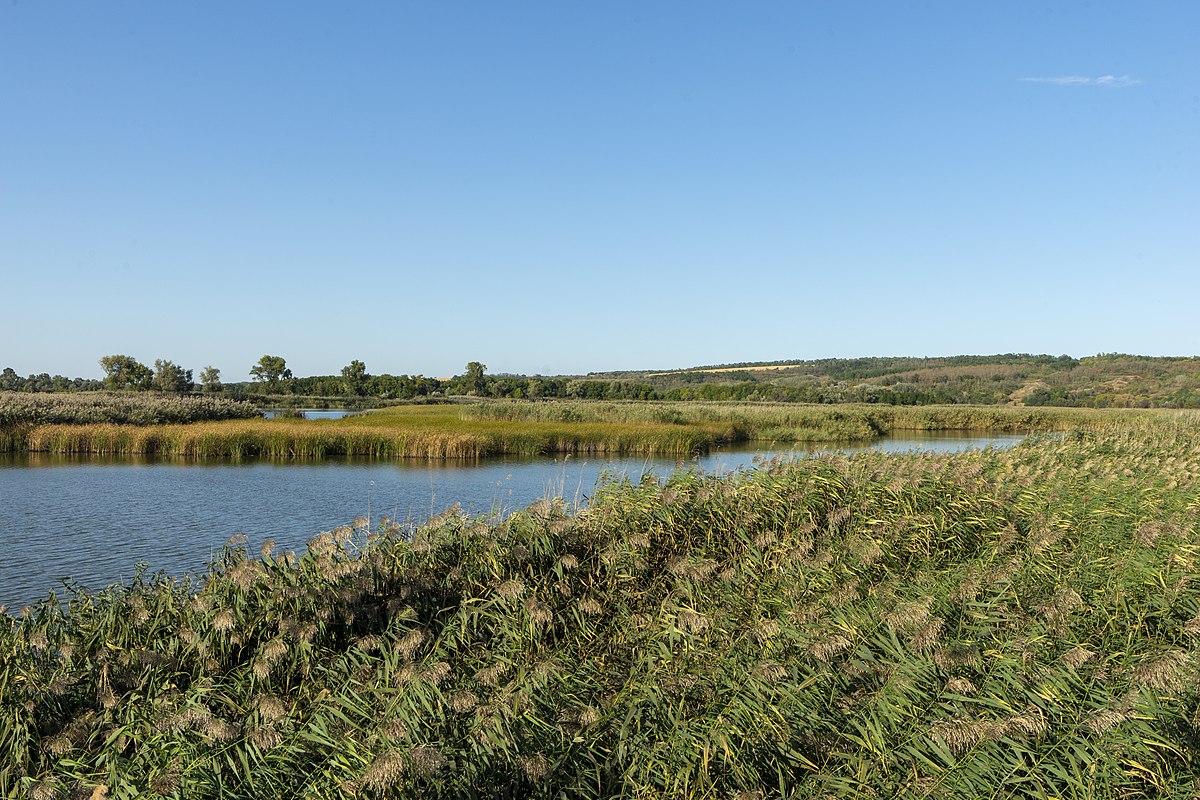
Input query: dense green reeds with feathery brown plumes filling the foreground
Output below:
<box><xmin>7</xmin><ymin>421</ymin><xmax>1200</xmax><ymax>799</ymax></box>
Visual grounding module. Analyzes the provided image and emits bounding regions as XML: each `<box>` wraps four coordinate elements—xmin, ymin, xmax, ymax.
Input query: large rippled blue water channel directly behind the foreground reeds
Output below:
<box><xmin>0</xmin><ymin>434</ymin><xmax>1022</xmax><ymax>608</ymax></box>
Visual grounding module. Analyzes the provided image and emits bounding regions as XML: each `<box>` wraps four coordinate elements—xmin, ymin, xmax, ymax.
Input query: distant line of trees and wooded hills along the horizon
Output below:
<box><xmin>7</xmin><ymin>353</ymin><xmax>1200</xmax><ymax>408</ymax></box>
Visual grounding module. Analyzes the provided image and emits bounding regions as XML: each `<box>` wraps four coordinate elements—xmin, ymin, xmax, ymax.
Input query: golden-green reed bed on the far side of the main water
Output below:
<box><xmin>0</xmin><ymin>402</ymin><xmax>1188</xmax><ymax>458</ymax></box>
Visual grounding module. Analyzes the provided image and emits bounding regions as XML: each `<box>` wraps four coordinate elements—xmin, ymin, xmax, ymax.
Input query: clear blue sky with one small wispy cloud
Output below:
<box><xmin>0</xmin><ymin>0</ymin><xmax>1200</xmax><ymax>380</ymax></box>
